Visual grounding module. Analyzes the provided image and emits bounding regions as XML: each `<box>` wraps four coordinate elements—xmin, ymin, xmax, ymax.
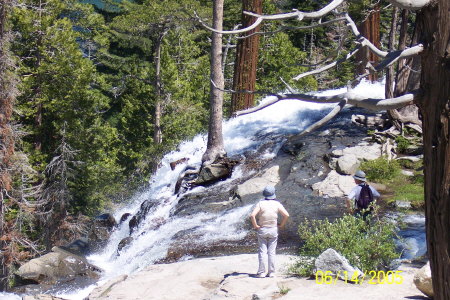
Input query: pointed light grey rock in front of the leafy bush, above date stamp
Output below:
<box><xmin>314</xmin><ymin>248</ymin><xmax>362</xmax><ymax>280</ymax></box>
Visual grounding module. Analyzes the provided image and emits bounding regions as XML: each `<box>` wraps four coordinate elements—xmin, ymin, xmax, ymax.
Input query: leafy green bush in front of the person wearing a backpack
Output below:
<box><xmin>290</xmin><ymin>215</ymin><xmax>399</xmax><ymax>276</ymax></box>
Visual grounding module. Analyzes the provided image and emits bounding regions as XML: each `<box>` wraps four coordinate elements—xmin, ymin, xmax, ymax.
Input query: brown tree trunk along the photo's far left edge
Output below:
<box><xmin>0</xmin><ymin>0</ymin><xmax>16</xmax><ymax>291</ymax></box>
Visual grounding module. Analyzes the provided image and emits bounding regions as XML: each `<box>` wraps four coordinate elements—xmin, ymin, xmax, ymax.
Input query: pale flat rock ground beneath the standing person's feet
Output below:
<box><xmin>89</xmin><ymin>254</ymin><xmax>428</xmax><ymax>300</ymax></box>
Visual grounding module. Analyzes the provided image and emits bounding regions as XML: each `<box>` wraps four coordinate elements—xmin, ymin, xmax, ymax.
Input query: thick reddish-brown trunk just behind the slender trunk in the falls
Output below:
<box><xmin>231</xmin><ymin>0</ymin><xmax>262</xmax><ymax>113</ymax></box>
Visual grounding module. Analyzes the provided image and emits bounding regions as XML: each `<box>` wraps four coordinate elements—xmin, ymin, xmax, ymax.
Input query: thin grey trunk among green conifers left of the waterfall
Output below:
<box><xmin>153</xmin><ymin>31</ymin><xmax>167</xmax><ymax>144</ymax></box>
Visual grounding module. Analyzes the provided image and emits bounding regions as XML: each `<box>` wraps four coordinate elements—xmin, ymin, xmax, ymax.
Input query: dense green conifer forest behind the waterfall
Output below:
<box><xmin>0</xmin><ymin>0</ymin><xmax>414</xmax><ymax>289</ymax></box>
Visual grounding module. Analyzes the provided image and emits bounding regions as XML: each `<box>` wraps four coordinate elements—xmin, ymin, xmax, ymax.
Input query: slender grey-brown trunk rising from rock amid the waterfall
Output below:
<box><xmin>202</xmin><ymin>0</ymin><xmax>226</xmax><ymax>165</ymax></box>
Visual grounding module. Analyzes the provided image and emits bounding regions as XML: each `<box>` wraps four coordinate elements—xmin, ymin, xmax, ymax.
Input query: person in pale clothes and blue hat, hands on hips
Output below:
<box><xmin>250</xmin><ymin>186</ymin><xmax>289</xmax><ymax>277</ymax></box>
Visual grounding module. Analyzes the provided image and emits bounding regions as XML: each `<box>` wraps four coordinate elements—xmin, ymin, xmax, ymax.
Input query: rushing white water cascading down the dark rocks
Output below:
<box><xmin>50</xmin><ymin>82</ymin><xmax>384</xmax><ymax>300</ymax></box>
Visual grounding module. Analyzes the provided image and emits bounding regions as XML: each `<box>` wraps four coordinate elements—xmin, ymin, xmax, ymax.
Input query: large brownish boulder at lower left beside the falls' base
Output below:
<box><xmin>16</xmin><ymin>247</ymin><xmax>98</xmax><ymax>284</ymax></box>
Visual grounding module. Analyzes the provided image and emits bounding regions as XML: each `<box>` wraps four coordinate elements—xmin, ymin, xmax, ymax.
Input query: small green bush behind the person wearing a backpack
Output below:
<box><xmin>360</xmin><ymin>157</ymin><xmax>401</xmax><ymax>182</ymax></box>
